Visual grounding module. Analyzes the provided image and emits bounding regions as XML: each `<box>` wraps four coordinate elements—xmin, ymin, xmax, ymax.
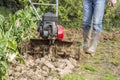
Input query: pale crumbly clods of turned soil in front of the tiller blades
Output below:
<box><xmin>8</xmin><ymin>55</ymin><xmax>77</xmax><ymax>80</ymax></box>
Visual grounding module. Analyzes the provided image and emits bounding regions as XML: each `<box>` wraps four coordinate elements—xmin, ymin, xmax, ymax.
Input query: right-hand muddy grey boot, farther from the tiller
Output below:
<box><xmin>86</xmin><ymin>31</ymin><xmax>100</xmax><ymax>56</ymax></box>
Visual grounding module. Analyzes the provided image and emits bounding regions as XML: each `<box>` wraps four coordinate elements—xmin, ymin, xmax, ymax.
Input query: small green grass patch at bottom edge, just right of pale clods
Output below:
<box><xmin>61</xmin><ymin>73</ymin><xmax>86</xmax><ymax>80</ymax></box>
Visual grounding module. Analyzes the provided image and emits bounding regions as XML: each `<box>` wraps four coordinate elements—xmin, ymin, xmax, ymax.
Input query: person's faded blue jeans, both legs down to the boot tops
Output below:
<box><xmin>83</xmin><ymin>0</ymin><xmax>106</xmax><ymax>32</ymax></box>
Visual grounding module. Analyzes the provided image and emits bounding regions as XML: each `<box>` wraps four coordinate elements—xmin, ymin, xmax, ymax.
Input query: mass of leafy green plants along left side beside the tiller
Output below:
<box><xmin>0</xmin><ymin>7</ymin><xmax>36</xmax><ymax>80</ymax></box>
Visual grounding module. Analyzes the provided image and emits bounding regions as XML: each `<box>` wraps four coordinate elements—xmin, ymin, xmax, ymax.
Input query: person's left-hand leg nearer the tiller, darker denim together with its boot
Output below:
<box><xmin>81</xmin><ymin>0</ymin><xmax>93</xmax><ymax>50</ymax></box>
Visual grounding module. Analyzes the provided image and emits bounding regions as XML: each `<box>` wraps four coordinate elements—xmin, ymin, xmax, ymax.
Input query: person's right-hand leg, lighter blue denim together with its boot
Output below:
<box><xmin>87</xmin><ymin>0</ymin><xmax>106</xmax><ymax>53</ymax></box>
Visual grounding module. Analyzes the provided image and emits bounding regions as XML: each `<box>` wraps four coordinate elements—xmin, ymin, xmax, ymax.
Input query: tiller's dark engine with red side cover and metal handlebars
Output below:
<box><xmin>29</xmin><ymin>0</ymin><xmax>64</xmax><ymax>44</ymax></box>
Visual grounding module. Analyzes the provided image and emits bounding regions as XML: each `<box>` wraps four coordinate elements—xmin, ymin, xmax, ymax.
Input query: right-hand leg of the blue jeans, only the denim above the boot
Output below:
<box><xmin>93</xmin><ymin>0</ymin><xmax>106</xmax><ymax>32</ymax></box>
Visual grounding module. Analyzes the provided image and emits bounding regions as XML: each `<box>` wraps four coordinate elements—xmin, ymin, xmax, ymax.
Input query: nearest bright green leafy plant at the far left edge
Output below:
<box><xmin>0</xmin><ymin>15</ymin><xmax>23</xmax><ymax>80</ymax></box>
